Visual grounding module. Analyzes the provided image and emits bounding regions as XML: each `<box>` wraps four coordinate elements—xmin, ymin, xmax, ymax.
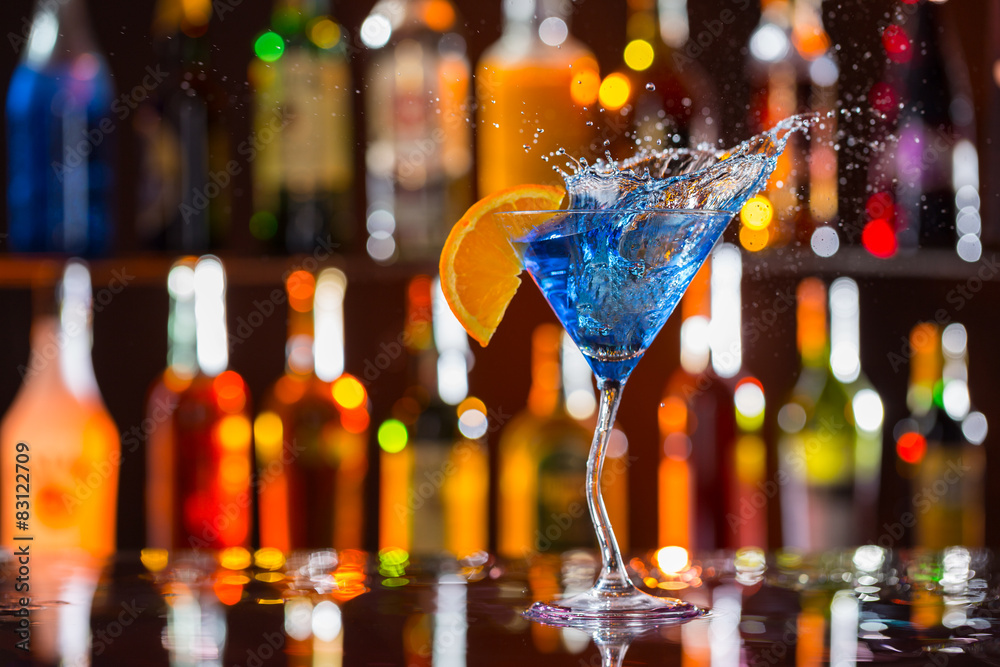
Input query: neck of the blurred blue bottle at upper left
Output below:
<box><xmin>24</xmin><ymin>0</ymin><xmax>97</xmax><ymax>67</ymax></box>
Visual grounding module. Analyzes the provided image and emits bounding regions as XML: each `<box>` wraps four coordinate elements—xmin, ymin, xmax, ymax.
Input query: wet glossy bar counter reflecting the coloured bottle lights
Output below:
<box><xmin>0</xmin><ymin>545</ymin><xmax>1000</xmax><ymax>667</ymax></box>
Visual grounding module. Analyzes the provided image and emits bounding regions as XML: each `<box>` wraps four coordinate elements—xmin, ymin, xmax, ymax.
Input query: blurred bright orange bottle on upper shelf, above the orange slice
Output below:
<box><xmin>476</xmin><ymin>0</ymin><xmax>601</xmax><ymax>197</ymax></box>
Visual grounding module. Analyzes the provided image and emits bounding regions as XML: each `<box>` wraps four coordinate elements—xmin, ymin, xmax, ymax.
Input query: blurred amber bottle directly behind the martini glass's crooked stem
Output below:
<box><xmin>497</xmin><ymin>324</ymin><xmax>628</xmax><ymax>558</ymax></box>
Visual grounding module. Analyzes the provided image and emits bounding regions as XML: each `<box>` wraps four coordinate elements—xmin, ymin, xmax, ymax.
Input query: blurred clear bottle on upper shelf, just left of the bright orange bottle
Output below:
<box><xmin>361</xmin><ymin>0</ymin><xmax>472</xmax><ymax>262</ymax></box>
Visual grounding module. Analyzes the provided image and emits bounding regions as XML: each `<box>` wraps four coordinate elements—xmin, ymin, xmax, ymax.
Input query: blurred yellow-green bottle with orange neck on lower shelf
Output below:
<box><xmin>778</xmin><ymin>278</ymin><xmax>882</xmax><ymax>551</ymax></box>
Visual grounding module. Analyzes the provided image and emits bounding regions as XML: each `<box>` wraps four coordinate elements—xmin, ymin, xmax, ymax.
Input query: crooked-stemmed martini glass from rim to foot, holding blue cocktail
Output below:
<box><xmin>497</xmin><ymin>208</ymin><xmax>733</xmax><ymax>628</ymax></box>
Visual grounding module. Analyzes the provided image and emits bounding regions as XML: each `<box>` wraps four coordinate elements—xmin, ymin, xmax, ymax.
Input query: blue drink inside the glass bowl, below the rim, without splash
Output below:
<box><xmin>522</xmin><ymin>211</ymin><xmax>732</xmax><ymax>381</ymax></box>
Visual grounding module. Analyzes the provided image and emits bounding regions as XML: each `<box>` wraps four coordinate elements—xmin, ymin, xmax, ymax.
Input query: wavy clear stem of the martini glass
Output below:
<box><xmin>587</xmin><ymin>378</ymin><xmax>635</xmax><ymax>597</ymax></box>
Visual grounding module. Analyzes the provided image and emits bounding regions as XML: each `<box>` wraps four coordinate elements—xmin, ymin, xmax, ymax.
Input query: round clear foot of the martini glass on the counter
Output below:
<box><xmin>524</xmin><ymin>590</ymin><xmax>708</xmax><ymax>629</ymax></box>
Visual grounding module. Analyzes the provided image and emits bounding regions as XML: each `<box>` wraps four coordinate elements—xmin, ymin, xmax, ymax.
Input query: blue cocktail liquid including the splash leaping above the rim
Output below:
<box><xmin>501</xmin><ymin>116</ymin><xmax>817</xmax><ymax>381</ymax></box>
